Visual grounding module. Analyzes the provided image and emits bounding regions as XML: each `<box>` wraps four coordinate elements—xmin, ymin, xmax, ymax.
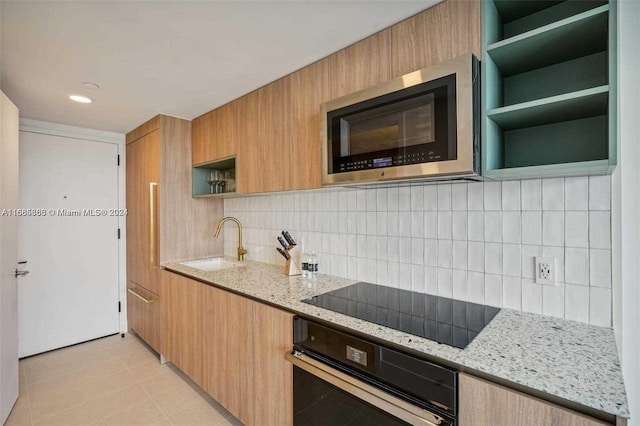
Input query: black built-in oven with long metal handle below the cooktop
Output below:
<box><xmin>287</xmin><ymin>318</ymin><xmax>457</xmax><ymax>426</ymax></box>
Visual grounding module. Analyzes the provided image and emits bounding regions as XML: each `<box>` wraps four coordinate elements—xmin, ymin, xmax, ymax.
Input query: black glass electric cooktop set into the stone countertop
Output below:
<box><xmin>303</xmin><ymin>282</ymin><xmax>500</xmax><ymax>349</ymax></box>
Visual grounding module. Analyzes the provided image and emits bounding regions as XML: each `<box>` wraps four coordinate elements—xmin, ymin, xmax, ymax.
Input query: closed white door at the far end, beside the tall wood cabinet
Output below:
<box><xmin>18</xmin><ymin>131</ymin><xmax>119</xmax><ymax>357</ymax></box>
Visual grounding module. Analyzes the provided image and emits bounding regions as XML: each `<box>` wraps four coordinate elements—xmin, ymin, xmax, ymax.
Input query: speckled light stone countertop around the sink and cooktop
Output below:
<box><xmin>162</xmin><ymin>258</ymin><xmax>629</xmax><ymax>418</ymax></box>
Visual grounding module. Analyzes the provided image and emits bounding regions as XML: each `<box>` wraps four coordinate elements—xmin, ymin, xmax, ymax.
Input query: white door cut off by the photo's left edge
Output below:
<box><xmin>0</xmin><ymin>92</ymin><xmax>18</xmax><ymax>424</ymax></box>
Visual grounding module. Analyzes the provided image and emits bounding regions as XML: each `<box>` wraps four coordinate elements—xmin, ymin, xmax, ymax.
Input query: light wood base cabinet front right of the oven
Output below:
<box><xmin>458</xmin><ymin>373</ymin><xmax>611</xmax><ymax>426</ymax></box>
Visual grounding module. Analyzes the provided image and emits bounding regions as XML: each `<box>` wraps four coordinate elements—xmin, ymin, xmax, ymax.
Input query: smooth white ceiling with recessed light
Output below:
<box><xmin>0</xmin><ymin>0</ymin><xmax>440</xmax><ymax>133</ymax></box>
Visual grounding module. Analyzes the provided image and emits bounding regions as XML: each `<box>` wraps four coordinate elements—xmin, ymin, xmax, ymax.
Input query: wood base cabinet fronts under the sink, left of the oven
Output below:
<box><xmin>161</xmin><ymin>271</ymin><xmax>293</xmax><ymax>425</ymax></box>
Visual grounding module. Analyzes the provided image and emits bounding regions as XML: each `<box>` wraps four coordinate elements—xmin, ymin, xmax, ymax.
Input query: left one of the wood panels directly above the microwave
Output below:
<box><xmin>329</xmin><ymin>29</ymin><xmax>391</xmax><ymax>99</ymax></box>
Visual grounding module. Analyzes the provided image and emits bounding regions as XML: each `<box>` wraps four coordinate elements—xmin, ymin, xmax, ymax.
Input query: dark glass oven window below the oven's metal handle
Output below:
<box><xmin>293</xmin><ymin>367</ymin><xmax>409</xmax><ymax>426</ymax></box>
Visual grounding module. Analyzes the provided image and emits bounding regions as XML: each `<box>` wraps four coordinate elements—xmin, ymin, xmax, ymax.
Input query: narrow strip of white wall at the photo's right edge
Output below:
<box><xmin>612</xmin><ymin>0</ymin><xmax>640</xmax><ymax>426</ymax></box>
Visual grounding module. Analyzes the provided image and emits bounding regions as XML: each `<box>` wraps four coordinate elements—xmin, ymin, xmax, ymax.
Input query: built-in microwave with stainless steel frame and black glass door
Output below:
<box><xmin>321</xmin><ymin>54</ymin><xmax>480</xmax><ymax>185</ymax></box>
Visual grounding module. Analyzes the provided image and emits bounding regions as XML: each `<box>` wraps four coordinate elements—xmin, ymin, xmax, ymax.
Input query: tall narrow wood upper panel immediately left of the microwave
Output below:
<box><xmin>288</xmin><ymin>59</ymin><xmax>331</xmax><ymax>189</ymax></box>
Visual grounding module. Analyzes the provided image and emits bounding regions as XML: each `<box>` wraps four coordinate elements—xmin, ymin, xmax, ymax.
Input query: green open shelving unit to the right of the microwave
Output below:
<box><xmin>482</xmin><ymin>0</ymin><xmax>616</xmax><ymax>179</ymax></box>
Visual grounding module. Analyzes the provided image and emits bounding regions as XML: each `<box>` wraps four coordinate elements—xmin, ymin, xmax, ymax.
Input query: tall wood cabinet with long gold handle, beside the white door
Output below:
<box><xmin>126</xmin><ymin>115</ymin><xmax>223</xmax><ymax>352</ymax></box>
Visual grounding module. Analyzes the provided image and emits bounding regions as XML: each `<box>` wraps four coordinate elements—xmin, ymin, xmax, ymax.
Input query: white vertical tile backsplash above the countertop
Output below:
<box><xmin>224</xmin><ymin>176</ymin><xmax>611</xmax><ymax>326</ymax></box>
